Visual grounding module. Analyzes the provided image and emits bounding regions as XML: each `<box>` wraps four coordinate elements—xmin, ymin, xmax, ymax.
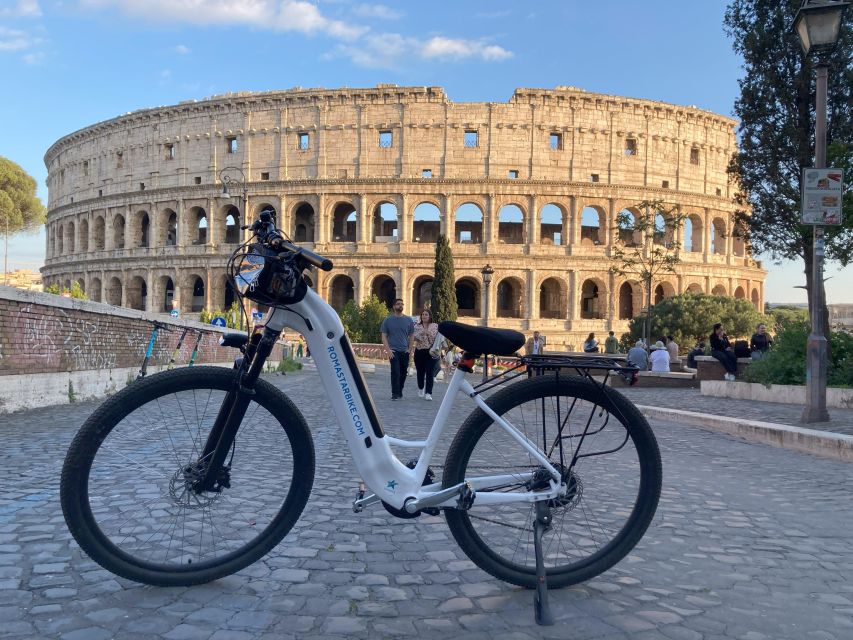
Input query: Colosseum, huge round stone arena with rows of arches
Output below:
<box><xmin>43</xmin><ymin>85</ymin><xmax>766</xmax><ymax>348</ymax></box>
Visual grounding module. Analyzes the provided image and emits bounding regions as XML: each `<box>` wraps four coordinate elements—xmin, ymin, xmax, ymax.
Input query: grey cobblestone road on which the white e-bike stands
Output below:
<box><xmin>0</xmin><ymin>368</ymin><xmax>853</xmax><ymax>640</ymax></box>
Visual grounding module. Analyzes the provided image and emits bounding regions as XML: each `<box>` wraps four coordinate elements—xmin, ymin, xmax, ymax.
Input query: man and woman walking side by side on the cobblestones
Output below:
<box><xmin>379</xmin><ymin>298</ymin><xmax>441</xmax><ymax>400</ymax></box>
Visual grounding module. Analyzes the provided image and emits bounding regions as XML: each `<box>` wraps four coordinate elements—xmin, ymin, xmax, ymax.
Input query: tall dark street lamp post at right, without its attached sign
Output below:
<box><xmin>793</xmin><ymin>0</ymin><xmax>848</xmax><ymax>422</ymax></box>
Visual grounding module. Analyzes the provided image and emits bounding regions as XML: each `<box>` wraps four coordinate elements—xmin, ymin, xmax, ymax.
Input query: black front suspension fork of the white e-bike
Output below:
<box><xmin>195</xmin><ymin>327</ymin><xmax>281</xmax><ymax>492</ymax></box>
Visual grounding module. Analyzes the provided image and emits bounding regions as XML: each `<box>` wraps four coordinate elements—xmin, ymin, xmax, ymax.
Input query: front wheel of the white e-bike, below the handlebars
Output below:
<box><xmin>60</xmin><ymin>367</ymin><xmax>314</xmax><ymax>586</ymax></box>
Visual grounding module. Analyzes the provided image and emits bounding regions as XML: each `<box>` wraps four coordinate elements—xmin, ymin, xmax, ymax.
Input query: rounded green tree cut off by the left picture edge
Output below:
<box><xmin>0</xmin><ymin>156</ymin><xmax>45</xmax><ymax>283</ymax></box>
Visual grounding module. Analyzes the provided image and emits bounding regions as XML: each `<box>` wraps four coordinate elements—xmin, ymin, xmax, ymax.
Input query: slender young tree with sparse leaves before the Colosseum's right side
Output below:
<box><xmin>610</xmin><ymin>200</ymin><xmax>685</xmax><ymax>344</ymax></box>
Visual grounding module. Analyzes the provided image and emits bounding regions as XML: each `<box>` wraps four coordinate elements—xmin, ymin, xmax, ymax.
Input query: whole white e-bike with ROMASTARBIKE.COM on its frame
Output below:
<box><xmin>61</xmin><ymin>214</ymin><xmax>661</xmax><ymax>624</ymax></box>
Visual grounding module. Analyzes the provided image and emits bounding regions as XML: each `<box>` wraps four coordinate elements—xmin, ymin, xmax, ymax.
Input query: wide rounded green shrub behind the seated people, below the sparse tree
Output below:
<box><xmin>623</xmin><ymin>292</ymin><xmax>766</xmax><ymax>348</ymax></box>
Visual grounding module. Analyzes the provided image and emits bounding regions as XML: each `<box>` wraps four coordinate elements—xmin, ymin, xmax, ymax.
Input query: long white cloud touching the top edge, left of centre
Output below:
<box><xmin>79</xmin><ymin>0</ymin><xmax>368</xmax><ymax>40</ymax></box>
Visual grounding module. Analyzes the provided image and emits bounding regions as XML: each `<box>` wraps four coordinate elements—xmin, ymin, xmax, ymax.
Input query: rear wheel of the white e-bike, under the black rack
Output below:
<box><xmin>443</xmin><ymin>375</ymin><xmax>661</xmax><ymax>588</ymax></box>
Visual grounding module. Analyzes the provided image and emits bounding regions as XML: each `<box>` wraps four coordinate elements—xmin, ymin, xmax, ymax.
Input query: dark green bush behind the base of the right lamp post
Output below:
<box><xmin>744</xmin><ymin>322</ymin><xmax>853</xmax><ymax>387</ymax></box>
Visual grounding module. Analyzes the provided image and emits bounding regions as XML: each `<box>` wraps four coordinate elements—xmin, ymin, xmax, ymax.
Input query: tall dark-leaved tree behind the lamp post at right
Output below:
<box><xmin>724</xmin><ymin>0</ymin><xmax>853</xmax><ymax>336</ymax></box>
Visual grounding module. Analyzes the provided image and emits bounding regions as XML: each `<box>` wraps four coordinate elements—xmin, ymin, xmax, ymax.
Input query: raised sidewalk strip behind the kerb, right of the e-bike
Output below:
<box><xmin>620</xmin><ymin>388</ymin><xmax>853</xmax><ymax>435</ymax></box>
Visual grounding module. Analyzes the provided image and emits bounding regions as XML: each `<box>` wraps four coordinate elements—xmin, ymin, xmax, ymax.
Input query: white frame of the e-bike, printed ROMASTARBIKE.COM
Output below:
<box><xmin>266</xmin><ymin>288</ymin><xmax>561</xmax><ymax>509</ymax></box>
